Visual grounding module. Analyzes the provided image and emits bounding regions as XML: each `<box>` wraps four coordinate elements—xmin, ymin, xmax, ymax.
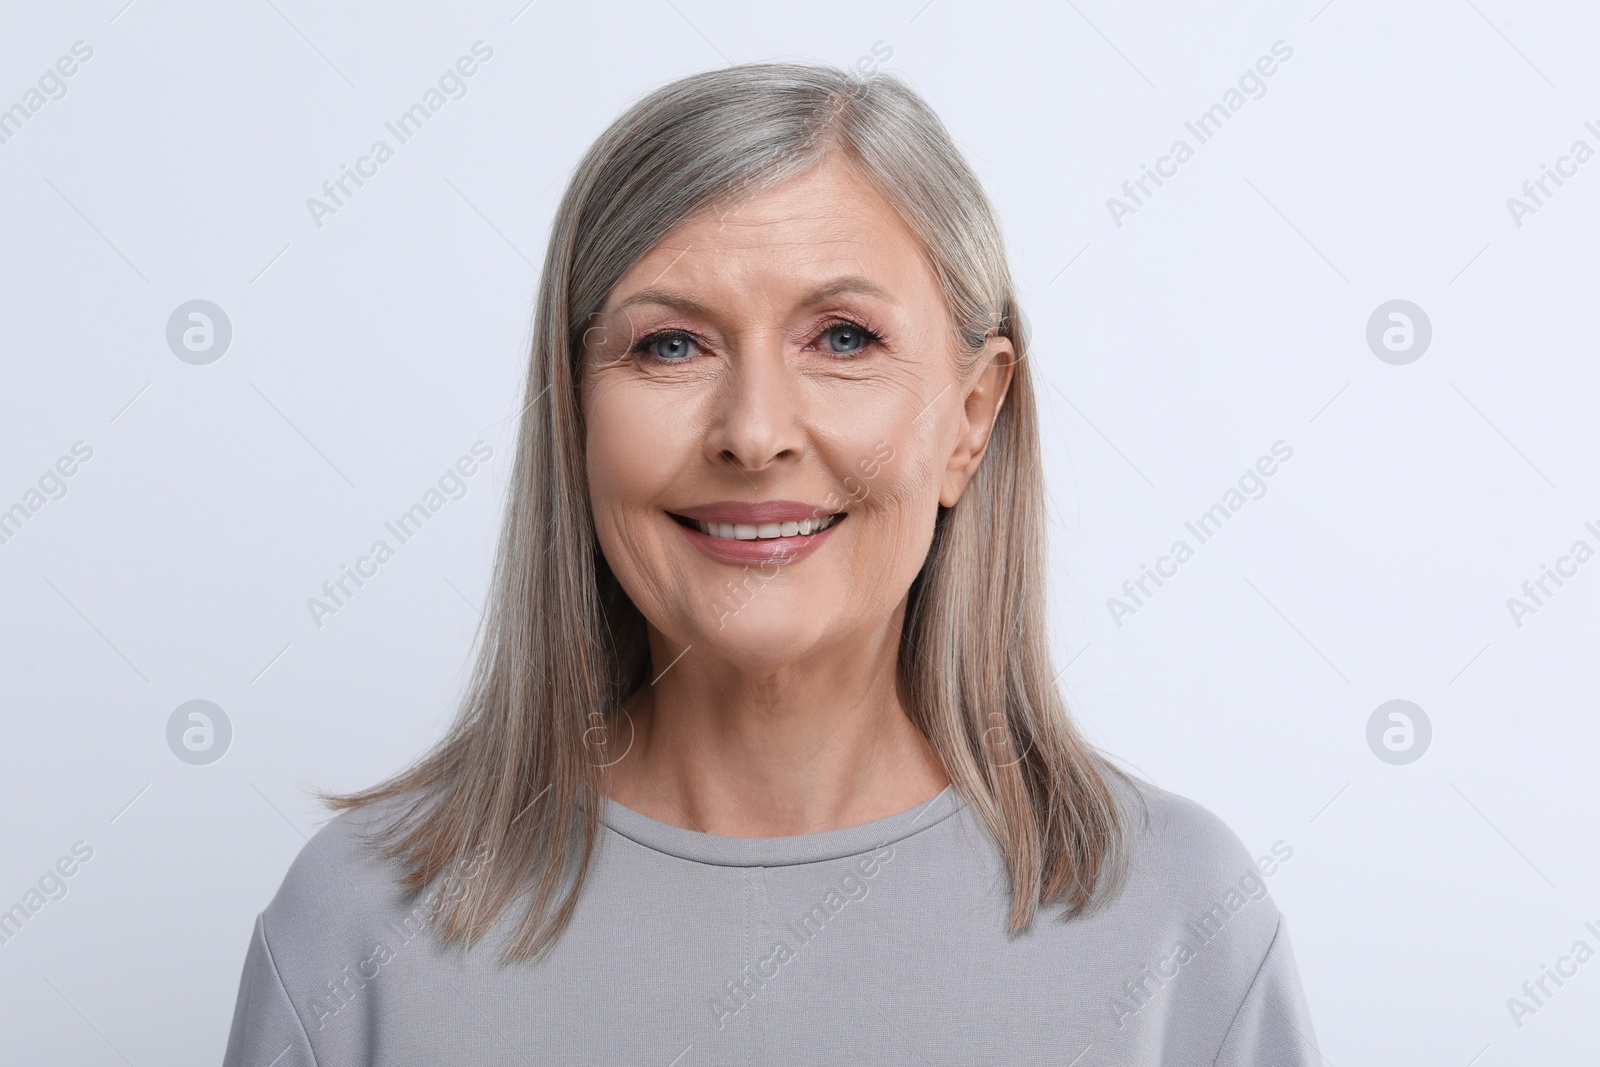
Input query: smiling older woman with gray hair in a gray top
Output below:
<box><xmin>226</xmin><ymin>64</ymin><xmax>1320</xmax><ymax>1067</ymax></box>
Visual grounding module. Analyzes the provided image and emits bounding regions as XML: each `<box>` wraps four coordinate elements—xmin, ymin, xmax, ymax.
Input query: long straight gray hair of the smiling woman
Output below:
<box><xmin>322</xmin><ymin>62</ymin><xmax>1128</xmax><ymax>963</ymax></box>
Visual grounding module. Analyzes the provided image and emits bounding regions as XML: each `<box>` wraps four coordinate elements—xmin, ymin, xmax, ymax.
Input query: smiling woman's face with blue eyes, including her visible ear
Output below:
<box><xmin>582</xmin><ymin>157</ymin><xmax>1011</xmax><ymax>670</ymax></box>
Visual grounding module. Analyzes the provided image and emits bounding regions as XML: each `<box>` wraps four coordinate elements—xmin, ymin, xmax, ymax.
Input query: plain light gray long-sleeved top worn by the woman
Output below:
<box><xmin>224</xmin><ymin>784</ymin><xmax>1322</xmax><ymax>1067</ymax></box>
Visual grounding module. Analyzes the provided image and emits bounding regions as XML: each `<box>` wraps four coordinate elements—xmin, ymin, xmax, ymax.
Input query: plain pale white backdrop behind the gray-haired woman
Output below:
<box><xmin>0</xmin><ymin>0</ymin><xmax>1600</xmax><ymax>1067</ymax></box>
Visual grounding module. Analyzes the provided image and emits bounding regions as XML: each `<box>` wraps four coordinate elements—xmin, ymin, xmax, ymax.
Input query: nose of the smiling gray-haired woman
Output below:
<box><xmin>706</xmin><ymin>342</ymin><xmax>805</xmax><ymax>472</ymax></box>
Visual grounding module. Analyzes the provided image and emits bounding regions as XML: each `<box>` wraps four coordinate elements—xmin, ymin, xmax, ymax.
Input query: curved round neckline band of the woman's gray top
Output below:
<box><xmin>600</xmin><ymin>782</ymin><xmax>963</xmax><ymax>867</ymax></box>
